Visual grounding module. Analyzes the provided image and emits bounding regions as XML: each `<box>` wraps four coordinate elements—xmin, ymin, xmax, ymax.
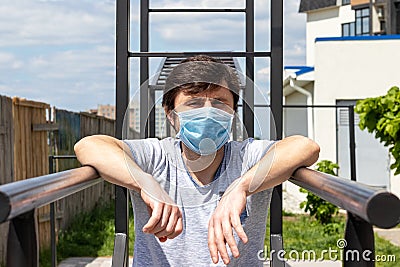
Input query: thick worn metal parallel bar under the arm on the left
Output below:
<box><xmin>0</xmin><ymin>166</ymin><xmax>102</xmax><ymax>223</ymax></box>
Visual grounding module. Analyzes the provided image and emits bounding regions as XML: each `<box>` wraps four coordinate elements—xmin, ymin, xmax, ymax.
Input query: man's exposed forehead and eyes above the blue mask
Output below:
<box><xmin>170</xmin><ymin>86</ymin><xmax>234</xmax><ymax>130</ymax></box>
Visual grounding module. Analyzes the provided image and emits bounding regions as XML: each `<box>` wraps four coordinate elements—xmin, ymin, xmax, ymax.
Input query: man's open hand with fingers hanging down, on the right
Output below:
<box><xmin>208</xmin><ymin>180</ymin><xmax>247</xmax><ymax>264</ymax></box>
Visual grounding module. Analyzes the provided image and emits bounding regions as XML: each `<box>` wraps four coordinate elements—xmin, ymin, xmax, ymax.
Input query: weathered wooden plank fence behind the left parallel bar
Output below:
<box><xmin>0</xmin><ymin>96</ymin><xmax>114</xmax><ymax>265</ymax></box>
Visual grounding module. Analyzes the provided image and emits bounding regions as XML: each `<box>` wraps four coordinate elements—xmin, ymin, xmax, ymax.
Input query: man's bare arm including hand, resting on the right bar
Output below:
<box><xmin>208</xmin><ymin>136</ymin><xmax>319</xmax><ymax>264</ymax></box>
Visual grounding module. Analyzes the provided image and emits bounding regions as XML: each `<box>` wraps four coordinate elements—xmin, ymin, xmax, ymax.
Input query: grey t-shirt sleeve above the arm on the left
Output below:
<box><xmin>124</xmin><ymin>138</ymin><xmax>161</xmax><ymax>174</ymax></box>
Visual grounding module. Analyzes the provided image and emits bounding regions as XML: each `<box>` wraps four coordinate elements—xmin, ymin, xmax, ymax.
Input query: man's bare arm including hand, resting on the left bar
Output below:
<box><xmin>74</xmin><ymin>135</ymin><xmax>182</xmax><ymax>241</ymax></box>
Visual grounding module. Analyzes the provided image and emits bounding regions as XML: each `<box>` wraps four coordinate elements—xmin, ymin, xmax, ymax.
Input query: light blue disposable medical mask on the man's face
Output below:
<box><xmin>176</xmin><ymin>107</ymin><xmax>233</xmax><ymax>155</ymax></box>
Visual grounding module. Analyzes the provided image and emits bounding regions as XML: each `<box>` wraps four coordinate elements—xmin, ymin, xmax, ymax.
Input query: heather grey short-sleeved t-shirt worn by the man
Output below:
<box><xmin>125</xmin><ymin>138</ymin><xmax>273</xmax><ymax>267</ymax></box>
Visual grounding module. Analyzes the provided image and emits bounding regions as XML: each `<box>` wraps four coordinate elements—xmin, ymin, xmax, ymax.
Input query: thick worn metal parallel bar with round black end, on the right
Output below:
<box><xmin>290</xmin><ymin>168</ymin><xmax>400</xmax><ymax>228</ymax></box>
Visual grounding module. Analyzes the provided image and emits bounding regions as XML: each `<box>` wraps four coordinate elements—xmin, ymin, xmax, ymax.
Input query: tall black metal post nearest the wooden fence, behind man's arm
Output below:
<box><xmin>114</xmin><ymin>0</ymin><xmax>130</xmax><ymax>266</ymax></box>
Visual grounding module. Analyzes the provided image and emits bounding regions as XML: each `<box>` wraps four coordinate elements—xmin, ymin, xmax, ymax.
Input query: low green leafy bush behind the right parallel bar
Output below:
<box><xmin>300</xmin><ymin>160</ymin><xmax>339</xmax><ymax>233</ymax></box>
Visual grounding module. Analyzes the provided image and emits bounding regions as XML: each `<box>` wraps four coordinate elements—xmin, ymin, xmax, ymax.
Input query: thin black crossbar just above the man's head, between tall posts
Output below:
<box><xmin>128</xmin><ymin>51</ymin><xmax>271</xmax><ymax>57</ymax></box>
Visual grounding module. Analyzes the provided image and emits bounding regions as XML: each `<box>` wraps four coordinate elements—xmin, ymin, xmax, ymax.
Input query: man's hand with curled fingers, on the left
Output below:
<box><xmin>140</xmin><ymin>184</ymin><xmax>183</xmax><ymax>242</ymax></box>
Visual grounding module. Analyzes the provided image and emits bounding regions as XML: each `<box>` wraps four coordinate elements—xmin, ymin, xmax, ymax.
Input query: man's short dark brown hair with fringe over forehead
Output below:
<box><xmin>162</xmin><ymin>55</ymin><xmax>240</xmax><ymax>111</ymax></box>
